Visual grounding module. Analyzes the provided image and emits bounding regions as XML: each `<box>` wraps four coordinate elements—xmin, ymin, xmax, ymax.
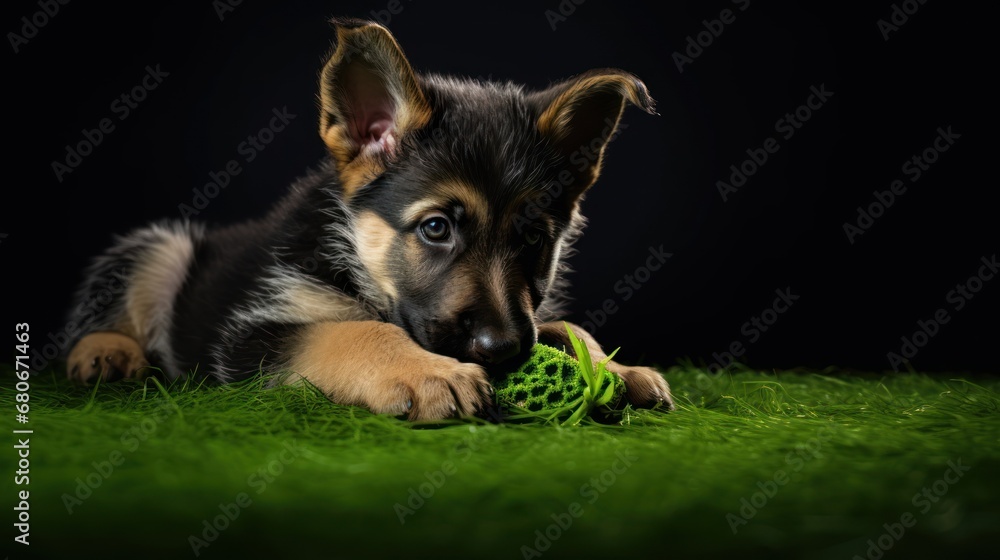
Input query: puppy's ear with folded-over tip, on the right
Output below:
<box><xmin>528</xmin><ymin>68</ymin><xmax>657</xmax><ymax>197</ymax></box>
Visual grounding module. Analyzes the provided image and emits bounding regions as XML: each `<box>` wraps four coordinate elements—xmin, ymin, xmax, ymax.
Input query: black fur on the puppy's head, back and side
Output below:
<box><xmin>71</xmin><ymin>22</ymin><xmax>652</xmax><ymax>390</ymax></box>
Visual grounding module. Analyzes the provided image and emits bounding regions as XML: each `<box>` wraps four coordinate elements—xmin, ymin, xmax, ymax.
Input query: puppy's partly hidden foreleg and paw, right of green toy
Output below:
<box><xmin>538</xmin><ymin>321</ymin><xmax>674</xmax><ymax>410</ymax></box>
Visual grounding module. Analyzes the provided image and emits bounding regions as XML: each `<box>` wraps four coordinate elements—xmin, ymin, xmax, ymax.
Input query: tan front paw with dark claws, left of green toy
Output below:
<box><xmin>365</xmin><ymin>352</ymin><xmax>492</xmax><ymax>420</ymax></box>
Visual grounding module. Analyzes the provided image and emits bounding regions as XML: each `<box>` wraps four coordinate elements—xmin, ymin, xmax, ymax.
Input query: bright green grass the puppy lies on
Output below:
<box><xmin>0</xmin><ymin>368</ymin><xmax>1000</xmax><ymax>559</ymax></box>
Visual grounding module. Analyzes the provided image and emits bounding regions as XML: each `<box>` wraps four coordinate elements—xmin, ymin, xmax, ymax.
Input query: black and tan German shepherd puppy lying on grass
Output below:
<box><xmin>67</xmin><ymin>19</ymin><xmax>673</xmax><ymax>420</ymax></box>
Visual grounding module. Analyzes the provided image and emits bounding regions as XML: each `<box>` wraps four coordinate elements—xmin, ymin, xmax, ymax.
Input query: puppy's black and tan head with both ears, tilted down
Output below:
<box><xmin>320</xmin><ymin>21</ymin><xmax>654</xmax><ymax>372</ymax></box>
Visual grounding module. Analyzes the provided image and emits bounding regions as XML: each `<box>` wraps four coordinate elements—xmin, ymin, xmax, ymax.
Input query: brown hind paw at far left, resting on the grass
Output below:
<box><xmin>66</xmin><ymin>332</ymin><xmax>149</xmax><ymax>382</ymax></box>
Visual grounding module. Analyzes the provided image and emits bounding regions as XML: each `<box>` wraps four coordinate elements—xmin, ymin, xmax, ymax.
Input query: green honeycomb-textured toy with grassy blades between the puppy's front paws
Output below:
<box><xmin>493</xmin><ymin>329</ymin><xmax>625</xmax><ymax>425</ymax></box>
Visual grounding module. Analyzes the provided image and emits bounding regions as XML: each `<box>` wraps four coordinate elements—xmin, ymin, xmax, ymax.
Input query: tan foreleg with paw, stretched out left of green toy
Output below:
<box><xmin>288</xmin><ymin>321</ymin><xmax>492</xmax><ymax>420</ymax></box>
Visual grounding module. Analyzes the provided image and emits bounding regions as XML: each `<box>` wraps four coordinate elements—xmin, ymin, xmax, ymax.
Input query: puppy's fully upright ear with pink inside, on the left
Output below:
<box><xmin>319</xmin><ymin>19</ymin><xmax>431</xmax><ymax>195</ymax></box>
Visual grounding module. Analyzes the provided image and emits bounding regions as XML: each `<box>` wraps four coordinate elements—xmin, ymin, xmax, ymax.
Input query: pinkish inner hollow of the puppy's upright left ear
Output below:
<box><xmin>344</xmin><ymin>65</ymin><xmax>396</xmax><ymax>156</ymax></box>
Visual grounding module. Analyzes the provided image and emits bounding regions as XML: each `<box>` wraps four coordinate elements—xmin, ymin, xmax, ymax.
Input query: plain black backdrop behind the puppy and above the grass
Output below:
<box><xmin>0</xmin><ymin>0</ymin><xmax>1000</xmax><ymax>372</ymax></box>
